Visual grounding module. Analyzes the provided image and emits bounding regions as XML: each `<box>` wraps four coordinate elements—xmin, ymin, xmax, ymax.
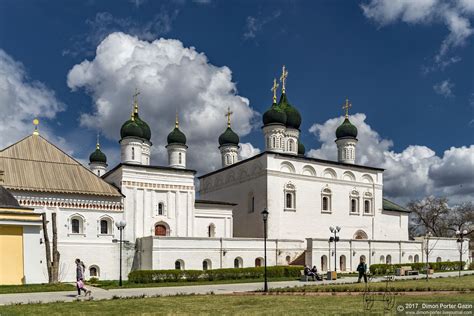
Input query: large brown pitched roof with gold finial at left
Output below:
<box><xmin>0</xmin><ymin>135</ymin><xmax>121</xmax><ymax>197</ymax></box>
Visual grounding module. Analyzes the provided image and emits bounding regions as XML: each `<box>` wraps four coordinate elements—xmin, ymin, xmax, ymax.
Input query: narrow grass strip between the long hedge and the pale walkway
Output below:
<box><xmin>91</xmin><ymin>277</ymin><xmax>299</xmax><ymax>290</ymax></box>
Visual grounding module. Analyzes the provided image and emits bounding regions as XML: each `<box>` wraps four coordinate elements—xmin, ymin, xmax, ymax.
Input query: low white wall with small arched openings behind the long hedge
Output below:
<box><xmin>142</xmin><ymin>237</ymin><xmax>304</xmax><ymax>270</ymax></box>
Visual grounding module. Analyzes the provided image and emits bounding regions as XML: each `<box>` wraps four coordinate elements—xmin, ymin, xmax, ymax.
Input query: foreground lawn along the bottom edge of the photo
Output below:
<box><xmin>0</xmin><ymin>293</ymin><xmax>474</xmax><ymax>316</ymax></box>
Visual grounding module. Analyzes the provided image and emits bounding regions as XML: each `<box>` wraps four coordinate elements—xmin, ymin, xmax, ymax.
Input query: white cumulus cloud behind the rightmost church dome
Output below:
<box><xmin>308</xmin><ymin>113</ymin><xmax>474</xmax><ymax>203</ymax></box>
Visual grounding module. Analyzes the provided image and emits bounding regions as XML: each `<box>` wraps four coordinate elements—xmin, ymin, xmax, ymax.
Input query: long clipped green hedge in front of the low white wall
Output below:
<box><xmin>128</xmin><ymin>266</ymin><xmax>304</xmax><ymax>283</ymax></box>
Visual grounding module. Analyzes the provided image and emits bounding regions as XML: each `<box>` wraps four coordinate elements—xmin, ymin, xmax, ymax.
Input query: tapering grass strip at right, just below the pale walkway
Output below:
<box><xmin>271</xmin><ymin>275</ymin><xmax>474</xmax><ymax>292</ymax></box>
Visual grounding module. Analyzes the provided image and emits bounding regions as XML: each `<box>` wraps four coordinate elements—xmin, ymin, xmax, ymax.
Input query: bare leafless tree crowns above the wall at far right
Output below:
<box><xmin>407</xmin><ymin>196</ymin><xmax>474</xmax><ymax>237</ymax></box>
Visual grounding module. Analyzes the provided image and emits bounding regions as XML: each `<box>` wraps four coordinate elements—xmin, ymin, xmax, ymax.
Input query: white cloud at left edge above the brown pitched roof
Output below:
<box><xmin>0</xmin><ymin>49</ymin><xmax>67</xmax><ymax>152</ymax></box>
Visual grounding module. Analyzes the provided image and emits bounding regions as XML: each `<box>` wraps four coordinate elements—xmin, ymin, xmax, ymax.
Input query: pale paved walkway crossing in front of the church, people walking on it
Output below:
<box><xmin>0</xmin><ymin>271</ymin><xmax>474</xmax><ymax>305</ymax></box>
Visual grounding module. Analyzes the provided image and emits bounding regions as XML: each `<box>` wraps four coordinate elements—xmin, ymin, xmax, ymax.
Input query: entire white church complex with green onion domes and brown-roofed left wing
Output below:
<box><xmin>0</xmin><ymin>70</ymin><xmax>468</xmax><ymax>283</ymax></box>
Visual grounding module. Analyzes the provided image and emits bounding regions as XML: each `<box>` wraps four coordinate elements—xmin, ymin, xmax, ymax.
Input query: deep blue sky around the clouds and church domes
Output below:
<box><xmin>0</xmin><ymin>0</ymin><xmax>474</xmax><ymax>204</ymax></box>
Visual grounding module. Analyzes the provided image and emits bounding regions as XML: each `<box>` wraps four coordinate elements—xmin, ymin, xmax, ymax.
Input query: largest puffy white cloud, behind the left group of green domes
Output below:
<box><xmin>67</xmin><ymin>32</ymin><xmax>258</xmax><ymax>172</ymax></box>
